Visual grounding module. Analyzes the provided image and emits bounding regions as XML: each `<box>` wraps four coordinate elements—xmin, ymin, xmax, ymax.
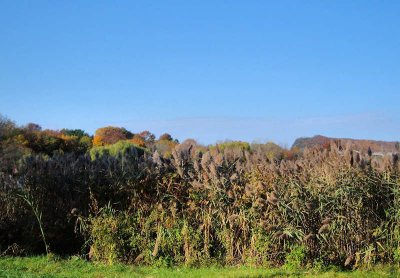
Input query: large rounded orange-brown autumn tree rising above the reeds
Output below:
<box><xmin>93</xmin><ymin>126</ymin><xmax>133</xmax><ymax>146</ymax></box>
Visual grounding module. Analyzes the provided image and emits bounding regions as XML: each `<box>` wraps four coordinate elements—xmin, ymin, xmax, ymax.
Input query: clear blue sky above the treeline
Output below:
<box><xmin>0</xmin><ymin>0</ymin><xmax>400</xmax><ymax>145</ymax></box>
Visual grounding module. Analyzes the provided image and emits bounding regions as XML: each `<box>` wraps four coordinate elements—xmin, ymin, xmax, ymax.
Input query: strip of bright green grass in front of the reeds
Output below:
<box><xmin>0</xmin><ymin>257</ymin><xmax>400</xmax><ymax>278</ymax></box>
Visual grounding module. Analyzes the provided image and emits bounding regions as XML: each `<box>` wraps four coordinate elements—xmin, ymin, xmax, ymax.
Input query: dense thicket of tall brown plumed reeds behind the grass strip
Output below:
<box><xmin>0</xmin><ymin>114</ymin><xmax>400</xmax><ymax>266</ymax></box>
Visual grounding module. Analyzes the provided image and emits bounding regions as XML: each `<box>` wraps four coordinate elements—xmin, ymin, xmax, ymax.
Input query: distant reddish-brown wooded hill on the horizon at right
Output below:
<box><xmin>292</xmin><ymin>135</ymin><xmax>399</xmax><ymax>153</ymax></box>
